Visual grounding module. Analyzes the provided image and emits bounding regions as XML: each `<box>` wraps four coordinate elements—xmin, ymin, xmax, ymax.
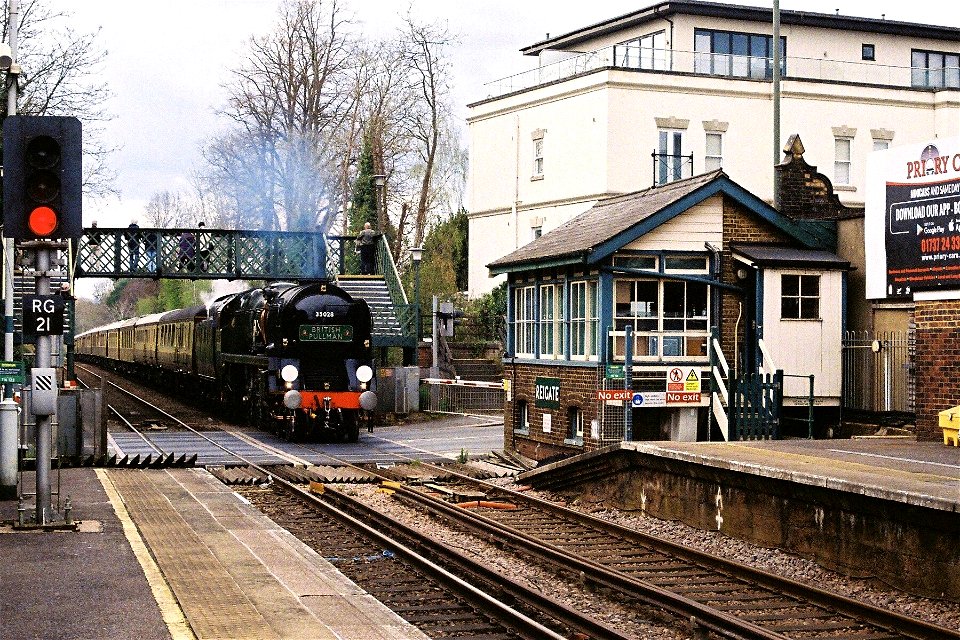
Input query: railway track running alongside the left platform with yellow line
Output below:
<box><xmin>77</xmin><ymin>368</ymin><xmax>626</xmax><ymax>640</ymax></box>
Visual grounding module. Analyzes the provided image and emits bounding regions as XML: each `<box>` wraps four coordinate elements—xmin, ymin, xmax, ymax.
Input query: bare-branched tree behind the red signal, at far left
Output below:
<box><xmin>0</xmin><ymin>0</ymin><xmax>116</xmax><ymax>197</ymax></box>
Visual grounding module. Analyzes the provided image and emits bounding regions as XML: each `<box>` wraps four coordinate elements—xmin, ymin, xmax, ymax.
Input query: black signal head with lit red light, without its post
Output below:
<box><xmin>3</xmin><ymin>116</ymin><xmax>83</xmax><ymax>241</ymax></box>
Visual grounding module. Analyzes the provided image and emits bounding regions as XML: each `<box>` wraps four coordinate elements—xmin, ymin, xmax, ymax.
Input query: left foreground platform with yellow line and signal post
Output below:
<box><xmin>0</xmin><ymin>468</ymin><xmax>426</xmax><ymax>640</ymax></box>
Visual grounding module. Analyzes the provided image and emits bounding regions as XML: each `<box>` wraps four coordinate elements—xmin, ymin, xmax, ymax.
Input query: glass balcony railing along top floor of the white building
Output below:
<box><xmin>483</xmin><ymin>45</ymin><xmax>957</xmax><ymax>99</ymax></box>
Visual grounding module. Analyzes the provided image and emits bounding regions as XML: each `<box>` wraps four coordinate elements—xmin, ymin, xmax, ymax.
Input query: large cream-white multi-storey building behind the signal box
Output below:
<box><xmin>468</xmin><ymin>0</ymin><xmax>960</xmax><ymax>296</ymax></box>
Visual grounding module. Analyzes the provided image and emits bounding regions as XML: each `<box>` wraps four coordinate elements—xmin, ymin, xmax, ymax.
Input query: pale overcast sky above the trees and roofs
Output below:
<box><xmin>73</xmin><ymin>0</ymin><xmax>944</xmax><ymax>227</ymax></box>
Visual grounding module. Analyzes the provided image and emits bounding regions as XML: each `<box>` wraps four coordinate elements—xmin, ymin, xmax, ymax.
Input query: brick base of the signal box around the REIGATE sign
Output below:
<box><xmin>503</xmin><ymin>364</ymin><xmax>601</xmax><ymax>460</ymax></box>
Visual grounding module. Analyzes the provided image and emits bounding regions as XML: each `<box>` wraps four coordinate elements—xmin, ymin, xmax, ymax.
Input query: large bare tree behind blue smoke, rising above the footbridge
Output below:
<box><xmin>205</xmin><ymin>0</ymin><xmax>357</xmax><ymax>231</ymax></box>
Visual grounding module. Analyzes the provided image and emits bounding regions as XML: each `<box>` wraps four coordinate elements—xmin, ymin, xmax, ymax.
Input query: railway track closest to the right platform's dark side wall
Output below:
<box><xmin>382</xmin><ymin>472</ymin><xmax>960</xmax><ymax>640</ymax></box>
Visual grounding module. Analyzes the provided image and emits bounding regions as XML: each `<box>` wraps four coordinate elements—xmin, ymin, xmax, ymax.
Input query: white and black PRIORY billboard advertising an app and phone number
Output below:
<box><xmin>864</xmin><ymin>138</ymin><xmax>960</xmax><ymax>299</ymax></box>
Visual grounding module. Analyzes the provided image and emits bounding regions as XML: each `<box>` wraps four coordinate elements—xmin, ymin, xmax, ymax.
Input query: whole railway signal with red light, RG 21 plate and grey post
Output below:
<box><xmin>0</xmin><ymin>115</ymin><xmax>83</xmax><ymax>526</ymax></box>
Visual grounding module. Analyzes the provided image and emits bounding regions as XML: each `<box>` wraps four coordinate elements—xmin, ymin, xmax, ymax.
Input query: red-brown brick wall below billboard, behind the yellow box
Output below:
<box><xmin>914</xmin><ymin>300</ymin><xmax>960</xmax><ymax>440</ymax></box>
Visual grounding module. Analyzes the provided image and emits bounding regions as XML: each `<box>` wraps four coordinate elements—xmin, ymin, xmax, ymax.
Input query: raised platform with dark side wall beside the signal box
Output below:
<box><xmin>518</xmin><ymin>437</ymin><xmax>960</xmax><ymax>602</ymax></box>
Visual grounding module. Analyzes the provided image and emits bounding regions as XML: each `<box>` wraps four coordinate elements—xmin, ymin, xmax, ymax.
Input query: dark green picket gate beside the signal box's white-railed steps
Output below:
<box><xmin>730</xmin><ymin>371</ymin><xmax>783</xmax><ymax>440</ymax></box>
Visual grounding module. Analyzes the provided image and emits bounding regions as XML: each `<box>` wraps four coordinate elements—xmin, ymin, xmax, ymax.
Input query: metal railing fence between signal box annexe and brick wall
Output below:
<box><xmin>843</xmin><ymin>331</ymin><xmax>914</xmax><ymax>412</ymax></box>
